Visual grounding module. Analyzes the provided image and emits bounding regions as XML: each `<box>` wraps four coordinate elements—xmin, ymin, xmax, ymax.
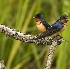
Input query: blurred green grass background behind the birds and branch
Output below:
<box><xmin>0</xmin><ymin>0</ymin><xmax>70</xmax><ymax>69</ymax></box>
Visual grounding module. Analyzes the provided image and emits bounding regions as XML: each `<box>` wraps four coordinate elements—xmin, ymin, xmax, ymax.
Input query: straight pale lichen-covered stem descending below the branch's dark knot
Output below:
<box><xmin>45</xmin><ymin>41</ymin><xmax>57</xmax><ymax>69</ymax></box>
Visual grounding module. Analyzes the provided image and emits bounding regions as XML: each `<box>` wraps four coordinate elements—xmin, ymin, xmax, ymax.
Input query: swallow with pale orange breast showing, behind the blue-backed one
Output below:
<box><xmin>33</xmin><ymin>13</ymin><xmax>50</xmax><ymax>32</ymax></box>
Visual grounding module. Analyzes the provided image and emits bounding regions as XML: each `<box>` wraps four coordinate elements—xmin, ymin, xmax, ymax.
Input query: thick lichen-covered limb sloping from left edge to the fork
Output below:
<box><xmin>0</xmin><ymin>24</ymin><xmax>63</xmax><ymax>45</ymax></box>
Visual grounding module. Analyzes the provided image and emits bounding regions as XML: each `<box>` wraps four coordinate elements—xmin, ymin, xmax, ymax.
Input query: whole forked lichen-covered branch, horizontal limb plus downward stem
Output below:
<box><xmin>0</xmin><ymin>24</ymin><xmax>65</xmax><ymax>69</ymax></box>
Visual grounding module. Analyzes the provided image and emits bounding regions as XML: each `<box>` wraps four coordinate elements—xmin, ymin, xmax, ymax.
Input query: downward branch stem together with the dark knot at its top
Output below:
<box><xmin>45</xmin><ymin>36</ymin><xmax>64</xmax><ymax>69</ymax></box>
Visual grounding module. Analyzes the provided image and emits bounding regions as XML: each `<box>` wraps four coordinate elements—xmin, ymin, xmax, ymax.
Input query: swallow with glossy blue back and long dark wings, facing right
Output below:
<box><xmin>33</xmin><ymin>14</ymin><xmax>68</xmax><ymax>39</ymax></box>
